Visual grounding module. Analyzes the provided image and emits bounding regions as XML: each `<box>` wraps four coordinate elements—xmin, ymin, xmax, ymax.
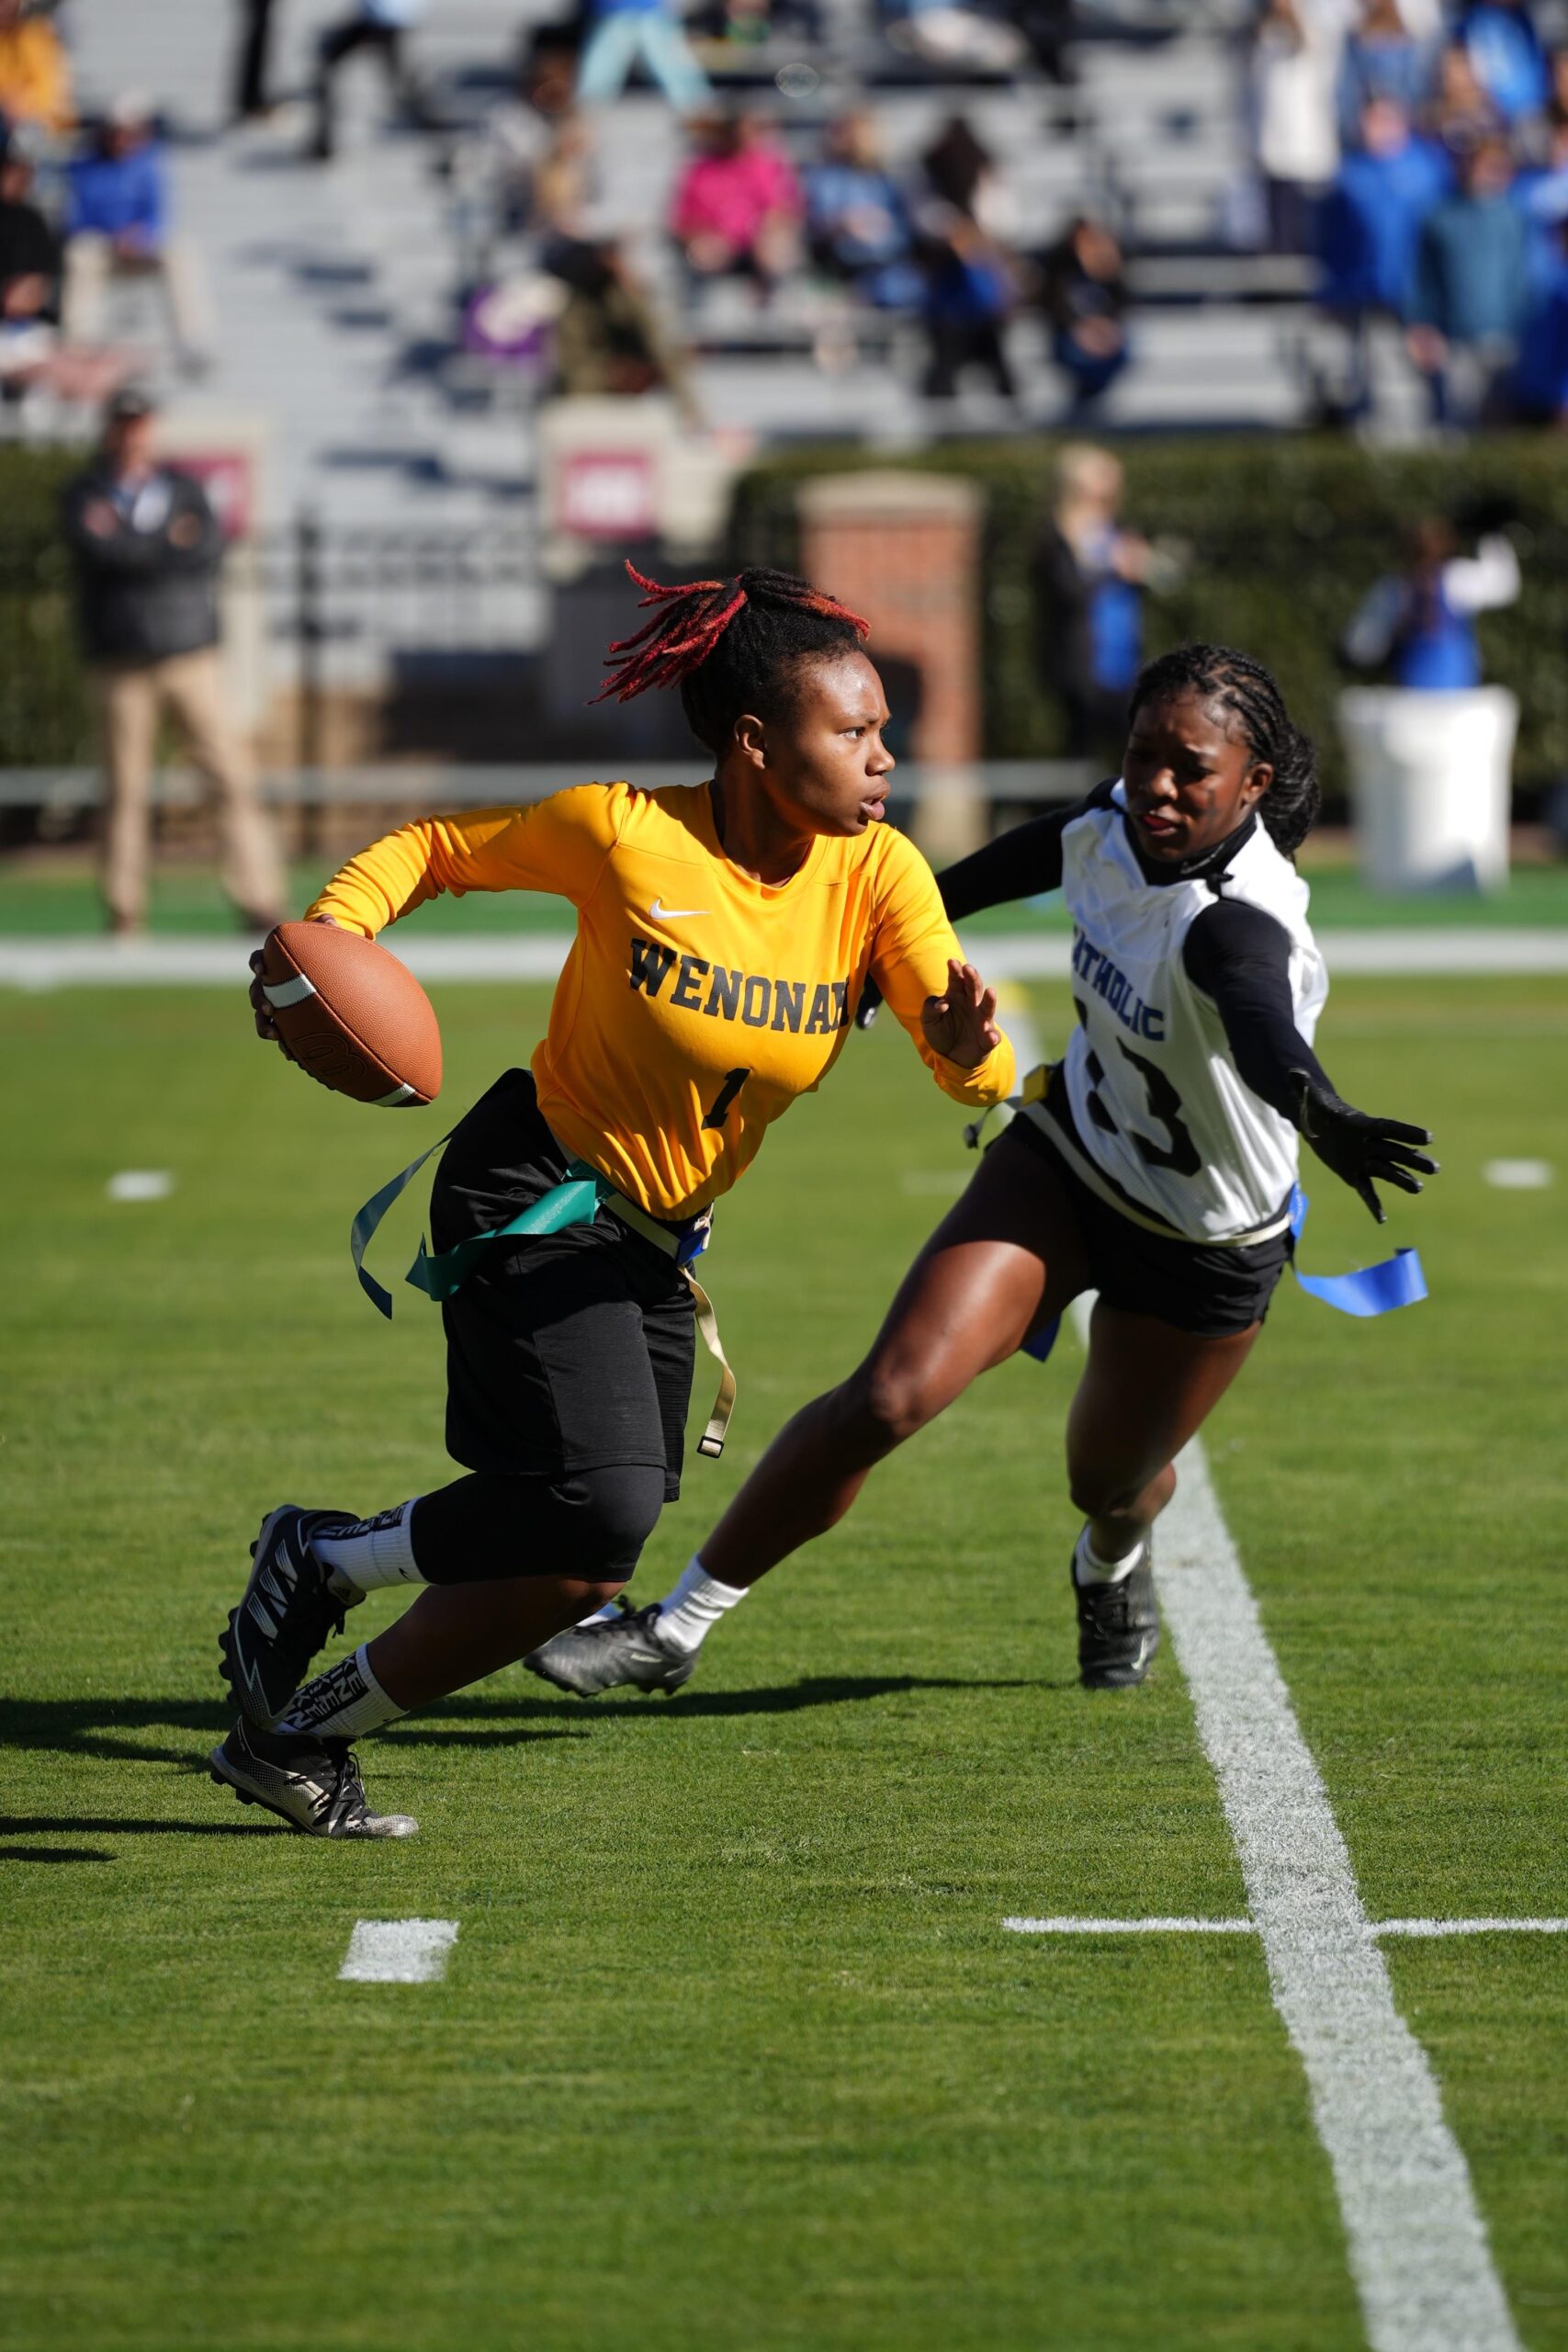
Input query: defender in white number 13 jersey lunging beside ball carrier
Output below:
<box><xmin>526</xmin><ymin>644</ymin><xmax>1437</xmax><ymax>1693</ymax></box>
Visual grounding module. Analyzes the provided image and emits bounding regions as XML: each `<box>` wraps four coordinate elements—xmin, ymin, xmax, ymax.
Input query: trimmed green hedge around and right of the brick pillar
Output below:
<box><xmin>731</xmin><ymin>435</ymin><xmax>1568</xmax><ymax>788</ymax></box>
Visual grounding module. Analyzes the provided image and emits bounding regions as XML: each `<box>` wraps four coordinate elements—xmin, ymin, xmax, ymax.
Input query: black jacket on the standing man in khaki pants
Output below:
<box><xmin>63</xmin><ymin>461</ymin><xmax>223</xmax><ymax>661</ymax></box>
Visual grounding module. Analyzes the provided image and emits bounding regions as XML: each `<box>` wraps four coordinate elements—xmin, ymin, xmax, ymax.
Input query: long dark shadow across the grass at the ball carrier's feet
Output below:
<box><xmin>0</xmin><ymin>1675</ymin><xmax>1043</xmax><ymax>1769</ymax></box>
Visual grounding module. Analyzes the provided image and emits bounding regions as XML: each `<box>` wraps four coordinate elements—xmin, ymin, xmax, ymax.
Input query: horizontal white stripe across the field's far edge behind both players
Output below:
<box><xmin>0</xmin><ymin>927</ymin><xmax>1568</xmax><ymax>990</ymax></box>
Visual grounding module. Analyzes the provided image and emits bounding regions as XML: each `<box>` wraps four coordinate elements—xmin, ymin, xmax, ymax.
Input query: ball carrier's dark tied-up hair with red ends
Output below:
<box><xmin>594</xmin><ymin>564</ymin><xmax>870</xmax><ymax>760</ymax></box>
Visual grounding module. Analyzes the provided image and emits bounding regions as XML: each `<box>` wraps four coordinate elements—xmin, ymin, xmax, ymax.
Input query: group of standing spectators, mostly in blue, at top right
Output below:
<box><xmin>1251</xmin><ymin>0</ymin><xmax>1568</xmax><ymax>428</ymax></box>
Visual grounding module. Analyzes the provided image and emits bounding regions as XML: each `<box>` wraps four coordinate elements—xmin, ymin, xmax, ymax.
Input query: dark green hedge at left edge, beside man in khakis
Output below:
<box><xmin>0</xmin><ymin>442</ymin><xmax>94</xmax><ymax>767</ymax></box>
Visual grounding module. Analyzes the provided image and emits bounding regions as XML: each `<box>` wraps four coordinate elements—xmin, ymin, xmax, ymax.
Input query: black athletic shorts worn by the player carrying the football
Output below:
<box><xmin>430</xmin><ymin>1070</ymin><xmax>696</xmax><ymax>1503</ymax></box>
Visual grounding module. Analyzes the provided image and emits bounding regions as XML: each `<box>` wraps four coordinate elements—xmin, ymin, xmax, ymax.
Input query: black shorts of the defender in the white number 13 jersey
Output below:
<box><xmin>1010</xmin><ymin>1091</ymin><xmax>1291</xmax><ymax>1339</ymax></box>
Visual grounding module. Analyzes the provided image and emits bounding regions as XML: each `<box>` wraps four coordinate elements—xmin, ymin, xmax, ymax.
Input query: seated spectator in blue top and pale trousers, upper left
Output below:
<box><xmin>63</xmin><ymin>94</ymin><xmax>214</xmax><ymax>374</ymax></box>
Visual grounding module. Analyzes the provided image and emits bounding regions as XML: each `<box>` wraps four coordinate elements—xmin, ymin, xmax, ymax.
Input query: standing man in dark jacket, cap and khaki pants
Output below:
<box><xmin>63</xmin><ymin>390</ymin><xmax>285</xmax><ymax>936</ymax></box>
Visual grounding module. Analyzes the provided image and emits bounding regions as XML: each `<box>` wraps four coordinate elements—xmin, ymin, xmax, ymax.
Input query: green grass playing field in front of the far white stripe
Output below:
<box><xmin>0</xmin><ymin>981</ymin><xmax>1568</xmax><ymax>2352</ymax></box>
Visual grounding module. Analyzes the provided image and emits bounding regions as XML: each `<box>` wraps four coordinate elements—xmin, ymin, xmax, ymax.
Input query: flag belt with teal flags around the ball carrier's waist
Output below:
<box><xmin>348</xmin><ymin>1129</ymin><xmax>736</xmax><ymax>1458</ymax></box>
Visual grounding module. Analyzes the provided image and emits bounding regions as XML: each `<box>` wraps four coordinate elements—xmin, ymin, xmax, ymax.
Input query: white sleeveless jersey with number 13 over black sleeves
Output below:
<box><xmin>1046</xmin><ymin>783</ymin><xmax>1328</xmax><ymax>1244</ymax></box>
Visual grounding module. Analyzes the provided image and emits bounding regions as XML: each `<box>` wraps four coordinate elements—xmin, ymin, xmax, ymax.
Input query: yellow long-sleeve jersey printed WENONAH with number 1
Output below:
<box><xmin>310</xmin><ymin>783</ymin><xmax>1013</xmax><ymax>1218</ymax></box>
